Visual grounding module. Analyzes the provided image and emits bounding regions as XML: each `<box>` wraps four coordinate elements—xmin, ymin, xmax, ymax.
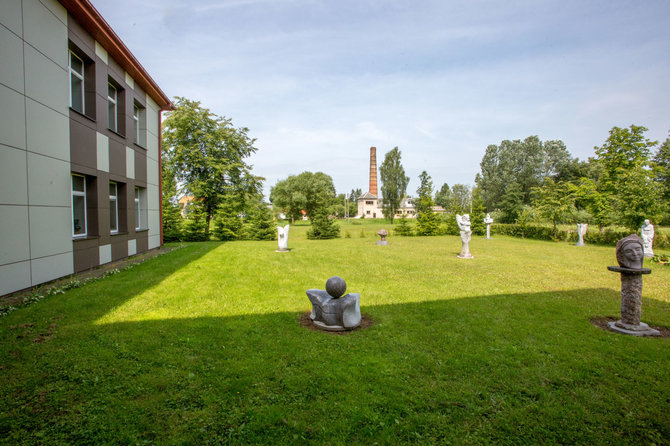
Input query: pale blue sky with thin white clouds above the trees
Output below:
<box><xmin>91</xmin><ymin>0</ymin><xmax>670</xmax><ymax>196</ymax></box>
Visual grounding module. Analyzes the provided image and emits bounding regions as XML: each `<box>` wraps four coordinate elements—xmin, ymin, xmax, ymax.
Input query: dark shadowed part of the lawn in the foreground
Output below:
<box><xmin>0</xmin><ymin>286</ymin><xmax>670</xmax><ymax>444</ymax></box>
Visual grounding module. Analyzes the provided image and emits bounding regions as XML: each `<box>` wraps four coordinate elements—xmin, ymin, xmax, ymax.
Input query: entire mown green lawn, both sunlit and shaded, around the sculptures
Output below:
<box><xmin>0</xmin><ymin>222</ymin><xmax>670</xmax><ymax>445</ymax></box>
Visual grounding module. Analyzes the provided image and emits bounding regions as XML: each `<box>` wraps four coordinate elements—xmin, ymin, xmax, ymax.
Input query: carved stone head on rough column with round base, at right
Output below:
<box><xmin>607</xmin><ymin>234</ymin><xmax>660</xmax><ymax>336</ymax></box>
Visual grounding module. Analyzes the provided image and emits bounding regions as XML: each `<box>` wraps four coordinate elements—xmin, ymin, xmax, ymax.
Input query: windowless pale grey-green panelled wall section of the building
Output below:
<box><xmin>0</xmin><ymin>0</ymin><xmax>74</xmax><ymax>295</ymax></box>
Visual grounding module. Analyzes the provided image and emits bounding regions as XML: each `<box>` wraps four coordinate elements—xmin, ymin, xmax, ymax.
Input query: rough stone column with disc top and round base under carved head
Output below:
<box><xmin>607</xmin><ymin>266</ymin><xmax>660</xmax><ymax>336</ymax></box>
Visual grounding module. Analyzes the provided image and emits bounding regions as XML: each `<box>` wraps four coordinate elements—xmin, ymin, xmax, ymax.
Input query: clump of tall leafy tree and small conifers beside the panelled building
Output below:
<box><xmin>161</xmin><ymin>97</ymin><xmax>276</xmax><ymax>242</ymax></box>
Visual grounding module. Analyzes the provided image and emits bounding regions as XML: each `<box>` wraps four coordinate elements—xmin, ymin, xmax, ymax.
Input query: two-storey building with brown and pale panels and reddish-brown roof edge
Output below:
<box><xmin>0</xmin><ymin>0</ymin><xmax>172</xmax><ymax>295</ymax></box>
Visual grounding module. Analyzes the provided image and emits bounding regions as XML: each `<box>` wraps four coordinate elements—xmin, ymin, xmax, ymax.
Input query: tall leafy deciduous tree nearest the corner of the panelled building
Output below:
<box><xmin>162</xmin><ymin>97</ymin><xmax>262</xmax><ymax>234</ymax></box>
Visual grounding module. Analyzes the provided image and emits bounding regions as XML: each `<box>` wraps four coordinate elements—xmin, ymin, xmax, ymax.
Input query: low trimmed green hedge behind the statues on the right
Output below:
<box><xmin>491</xmin><ymin>223</ymin><xmax>670</xmax><ymax>249</ymax></box>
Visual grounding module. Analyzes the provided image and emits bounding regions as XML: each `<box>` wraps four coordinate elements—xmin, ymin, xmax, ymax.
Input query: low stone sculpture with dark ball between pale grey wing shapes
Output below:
<box><xmin>307</xmin><ymin>276</ymin><xmax>361</xmax><ymax>331</ymax></box>
